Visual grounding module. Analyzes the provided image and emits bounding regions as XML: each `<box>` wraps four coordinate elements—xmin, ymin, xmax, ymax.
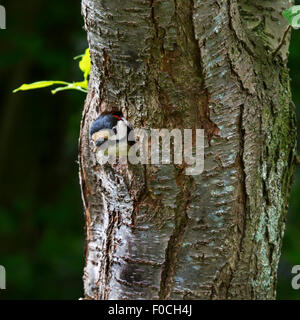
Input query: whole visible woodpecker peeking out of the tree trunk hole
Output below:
<box><xmin>90</xmin><ymin>112</ymin><xmax>134</xmax><ymax>156</ymax></box>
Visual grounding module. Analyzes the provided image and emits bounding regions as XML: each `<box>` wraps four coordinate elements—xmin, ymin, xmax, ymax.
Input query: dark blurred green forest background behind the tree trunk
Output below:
<box><xmin>0</xmin><ymin>0</ymin><xmax>300</xmax><ymax>299</ymax></box>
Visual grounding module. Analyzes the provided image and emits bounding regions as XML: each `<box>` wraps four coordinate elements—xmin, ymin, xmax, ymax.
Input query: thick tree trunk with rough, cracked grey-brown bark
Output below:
<box><xmin>79</xmin><ymin>0</ymin><xmax>296</xmax><ymax>299</ymax></box>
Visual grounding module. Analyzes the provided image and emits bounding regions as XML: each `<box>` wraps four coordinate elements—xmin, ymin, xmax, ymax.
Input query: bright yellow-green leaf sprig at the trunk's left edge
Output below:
<box><xmin>13</xmin><ymin>48</ymin><xmax>91</xmax><ymax>94</ymax></box>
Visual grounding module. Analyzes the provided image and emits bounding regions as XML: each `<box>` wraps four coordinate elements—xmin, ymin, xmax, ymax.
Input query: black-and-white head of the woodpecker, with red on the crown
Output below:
<box><xmin>90</xmin><ymin>112</ymin><xmax>132</xmax><ymax>151</ymax></box>
